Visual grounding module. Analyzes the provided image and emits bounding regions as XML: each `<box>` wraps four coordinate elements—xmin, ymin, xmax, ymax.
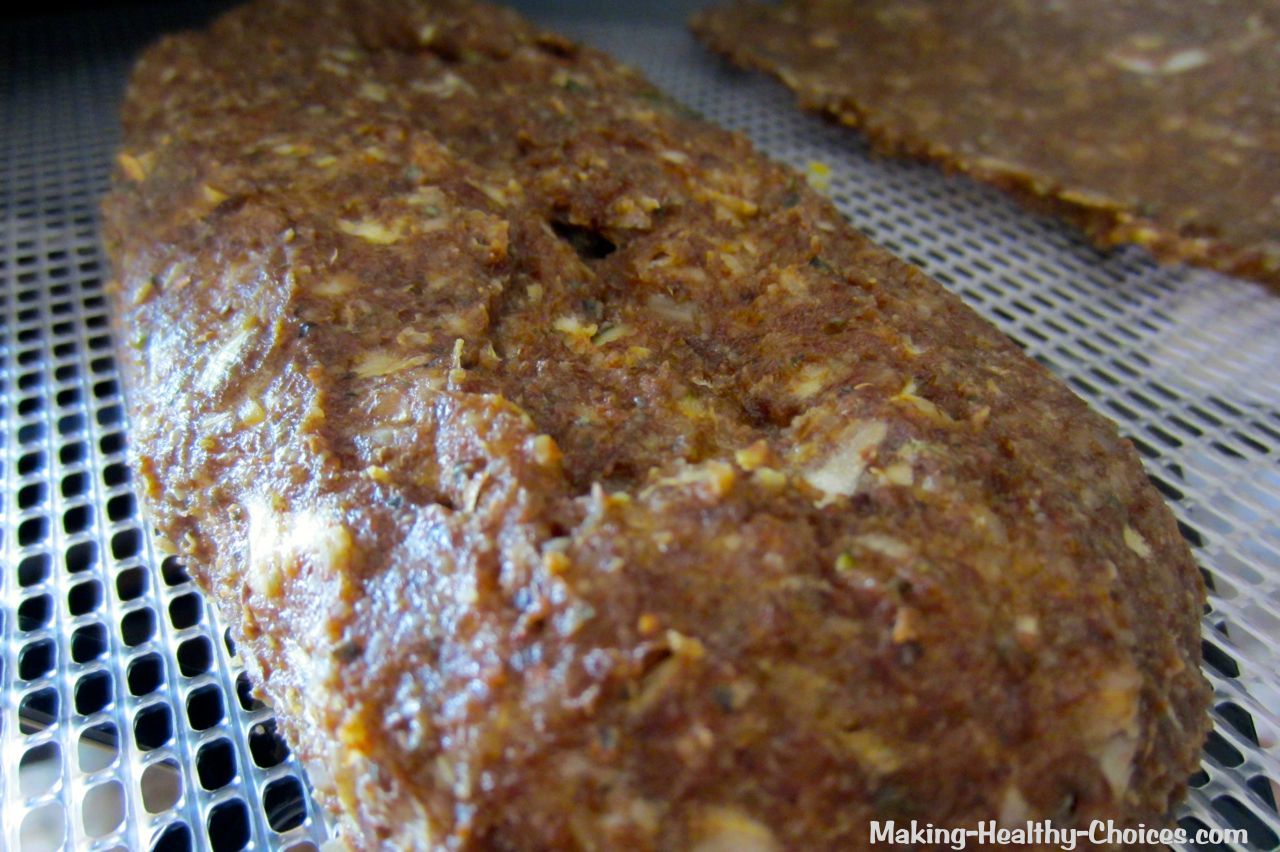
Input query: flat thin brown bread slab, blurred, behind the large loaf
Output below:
<box><xmin>694</xmin><ymin>0</ymin><xmax>1280</xmax><ymax>285</ymax></box>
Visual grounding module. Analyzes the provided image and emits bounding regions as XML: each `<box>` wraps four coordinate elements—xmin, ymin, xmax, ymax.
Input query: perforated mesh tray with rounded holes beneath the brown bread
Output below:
<box><xmin>0</xmin><ymin>6</ymin><xmax>1280</xmax><ymax>849</ymax></box>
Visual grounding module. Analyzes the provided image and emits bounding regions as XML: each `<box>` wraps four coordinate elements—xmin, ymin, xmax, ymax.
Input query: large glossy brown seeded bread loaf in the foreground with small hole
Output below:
<box><xmin>104</xmin><ymin>0</ymin><xmax>1207</xmax><ymax>852</ymax></box>
